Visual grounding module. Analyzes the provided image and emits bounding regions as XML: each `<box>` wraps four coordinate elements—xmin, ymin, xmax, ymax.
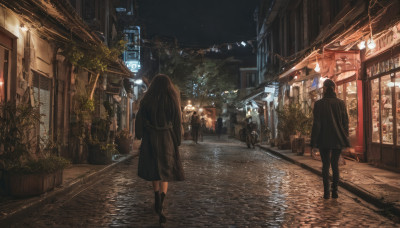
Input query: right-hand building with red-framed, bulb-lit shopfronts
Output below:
<box><xmin>257</xmin><ymin>0</ymin><xmax>400</xmax><ymax>170</ymax></box>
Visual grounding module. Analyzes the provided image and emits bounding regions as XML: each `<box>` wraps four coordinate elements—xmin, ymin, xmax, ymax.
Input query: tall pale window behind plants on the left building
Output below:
<box><xmin>33</xmin><ymin>72</ymin><xmax>51</xmax><ymax>139</ymax></box>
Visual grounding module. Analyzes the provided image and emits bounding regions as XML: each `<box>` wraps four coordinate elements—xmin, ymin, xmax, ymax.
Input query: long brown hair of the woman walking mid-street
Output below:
<box><xmin>142</xmin><ymin>74</ymin><xmax>180</xmax><ymax>110</ymax></box>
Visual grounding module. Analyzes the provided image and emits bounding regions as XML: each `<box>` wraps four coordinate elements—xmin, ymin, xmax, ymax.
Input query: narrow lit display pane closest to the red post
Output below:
<box><xmin>371</xmin><ymin>78</ymin><xmax>381</xmax><ymax>143</ymax></box>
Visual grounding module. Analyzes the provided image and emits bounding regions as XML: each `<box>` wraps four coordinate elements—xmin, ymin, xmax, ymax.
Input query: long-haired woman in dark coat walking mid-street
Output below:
<box><xmin>135</xmin><ymin>74</ymin><xmax>184</xmax><ymax>224</ymax></box>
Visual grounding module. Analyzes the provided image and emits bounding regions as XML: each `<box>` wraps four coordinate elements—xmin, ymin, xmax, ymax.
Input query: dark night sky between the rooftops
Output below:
<box><xmin>137</xmin><ymin>0</ymin><xmax>259</xmax><ymax>47</ymax></box>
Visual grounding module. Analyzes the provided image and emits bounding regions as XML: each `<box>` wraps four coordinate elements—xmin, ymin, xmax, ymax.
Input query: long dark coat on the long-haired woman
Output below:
<box><xmin>135</xmin><ymin>96</ymin><xmax>184</xmax><ymax>181</ymax></box>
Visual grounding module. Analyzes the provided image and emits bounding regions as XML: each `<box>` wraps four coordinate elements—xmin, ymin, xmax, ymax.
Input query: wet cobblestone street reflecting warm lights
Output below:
<box><xmin>13</xmin><ymin>137</ymin><xmax>398</xmax><ymax>228</ymax></box>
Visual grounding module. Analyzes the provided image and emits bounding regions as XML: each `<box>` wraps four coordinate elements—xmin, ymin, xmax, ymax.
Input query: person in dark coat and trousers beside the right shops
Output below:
<box><xmin>311</xmin><ymin>79</ymin><xmax>350</xmax><ymax>199</ymax></box>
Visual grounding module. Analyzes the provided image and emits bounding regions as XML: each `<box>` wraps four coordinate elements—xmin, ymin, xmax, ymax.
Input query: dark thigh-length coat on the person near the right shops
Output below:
<box><xmin>311</xmin><ymin>94</ymin><xmax>350</xmax><ymax>149</ymax></box>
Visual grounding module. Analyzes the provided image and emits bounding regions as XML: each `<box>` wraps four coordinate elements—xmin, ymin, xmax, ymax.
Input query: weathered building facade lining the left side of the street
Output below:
<box><xmin>0</xmin><ymin>0</ymin><xmax>131</xmax><ymax>162</ymax></box>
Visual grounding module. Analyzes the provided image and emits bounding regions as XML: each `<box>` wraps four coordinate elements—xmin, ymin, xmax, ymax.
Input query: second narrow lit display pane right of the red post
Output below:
<box><xmin>380</xmin><ymin>75</ymin><xmax>394</xmax><ymax>144</ymax></box>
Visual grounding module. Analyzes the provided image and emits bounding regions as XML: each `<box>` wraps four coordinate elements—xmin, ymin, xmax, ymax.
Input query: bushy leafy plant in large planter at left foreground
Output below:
<box><xmin>0</xmin><ymin>101</ymin><xmax>69</xmax><ymax>197</ymax></box>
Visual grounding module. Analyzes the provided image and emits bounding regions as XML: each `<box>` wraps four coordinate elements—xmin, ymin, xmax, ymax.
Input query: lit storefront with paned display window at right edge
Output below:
<box><xmin>365</xmin><ymin>28</ymin><xmax>400</xmax><ymax>170</ymax></box>
